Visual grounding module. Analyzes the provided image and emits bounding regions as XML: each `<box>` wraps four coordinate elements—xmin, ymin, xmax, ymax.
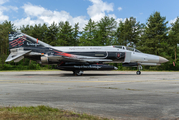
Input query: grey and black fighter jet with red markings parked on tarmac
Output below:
<box><xmin>5</xmin><ymin>32</ymin><xmax>168</xmax><ymax>76</ymax></box>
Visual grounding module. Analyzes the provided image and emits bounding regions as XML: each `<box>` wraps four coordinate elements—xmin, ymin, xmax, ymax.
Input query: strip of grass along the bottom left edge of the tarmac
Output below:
<box><xmin>0</xmin><ymin>106</ymin><xmax>108</xmax><ymax>120</ymax></box>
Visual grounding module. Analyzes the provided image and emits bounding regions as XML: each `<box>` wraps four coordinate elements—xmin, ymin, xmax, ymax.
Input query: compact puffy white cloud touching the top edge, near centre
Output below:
<box><xmin>87</xmin><ymin>0</ymin><xmax>113</xmax><ymax>21</ymax></box>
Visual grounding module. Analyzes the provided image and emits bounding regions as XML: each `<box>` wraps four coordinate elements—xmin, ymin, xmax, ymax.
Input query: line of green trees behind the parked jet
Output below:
<box><xmin>0</xmin><ymin>12</ymin><xmax>179</xmax><ymax>70</ymax></box>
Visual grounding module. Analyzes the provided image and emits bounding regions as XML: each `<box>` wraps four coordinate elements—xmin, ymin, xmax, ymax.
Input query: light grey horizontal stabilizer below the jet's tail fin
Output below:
<box><xmin>5</xmin><ymin>50</ymin><xmax>31</xmax><ymax>62</ymax></box>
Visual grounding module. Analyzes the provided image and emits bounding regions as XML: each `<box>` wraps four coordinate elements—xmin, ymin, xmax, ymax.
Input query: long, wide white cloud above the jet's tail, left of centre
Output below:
<box><xmin>14</xmin><ymin>3</ymin><xmax>88</xmax><ymax>30</ymax></box>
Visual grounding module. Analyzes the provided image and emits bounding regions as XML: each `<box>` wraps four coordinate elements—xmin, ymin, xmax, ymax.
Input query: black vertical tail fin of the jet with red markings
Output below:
<box><xmin>9</xmin><ymin>32</ymin><xmax>50</xmax><ymax>49</ymax></box>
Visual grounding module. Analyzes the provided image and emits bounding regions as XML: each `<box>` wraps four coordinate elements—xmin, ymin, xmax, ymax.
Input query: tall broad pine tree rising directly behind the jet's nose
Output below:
<box><xmin>140</xmin><ymin>12</ymin><xmax>168</xmax><ymax>55</ymax></box>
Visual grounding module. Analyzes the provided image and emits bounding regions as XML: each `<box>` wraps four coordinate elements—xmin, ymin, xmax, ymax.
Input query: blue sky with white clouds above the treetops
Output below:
<box><xmin>0</xmin><ymin>0</ymin><xmax>179</xmax><ymax>30</ymax></box>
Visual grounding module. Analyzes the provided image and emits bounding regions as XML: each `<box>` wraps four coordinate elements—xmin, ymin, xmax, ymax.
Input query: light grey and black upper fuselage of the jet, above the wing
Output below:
<box><xmin>49</xmin><ymin>46</ymin><xmax>167</xmax><ymax>65</ymax></box>
